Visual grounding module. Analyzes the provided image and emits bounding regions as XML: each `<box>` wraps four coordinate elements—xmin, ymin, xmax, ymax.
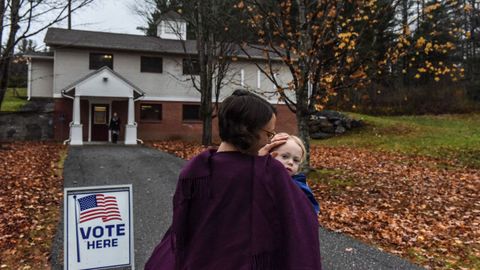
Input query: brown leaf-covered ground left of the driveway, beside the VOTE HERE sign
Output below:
<box><xmin>0</xmin><ymin>142</ymin><xmax>66</xmax><ymax>269</ymax></box>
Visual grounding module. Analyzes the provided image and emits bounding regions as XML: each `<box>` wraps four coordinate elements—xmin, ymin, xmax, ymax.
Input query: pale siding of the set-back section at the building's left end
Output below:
<box><xmin>29</xmin><ymin>59</ymin><xmax>53</xmax><ymax>97</ymax></box>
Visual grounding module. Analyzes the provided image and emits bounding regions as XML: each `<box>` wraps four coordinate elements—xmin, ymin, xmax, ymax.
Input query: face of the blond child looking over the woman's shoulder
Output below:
<box><xmin>273</xmin><ymin>139</ymin><xmax>303</xmax><ymax>176</ymax></box>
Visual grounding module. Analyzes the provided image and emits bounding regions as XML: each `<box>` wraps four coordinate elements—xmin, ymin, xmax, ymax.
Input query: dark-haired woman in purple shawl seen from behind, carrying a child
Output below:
<box><xmin>145</xmin><ymin>90</ymin><xmax>321</xmax><ymax>270</ymax></box>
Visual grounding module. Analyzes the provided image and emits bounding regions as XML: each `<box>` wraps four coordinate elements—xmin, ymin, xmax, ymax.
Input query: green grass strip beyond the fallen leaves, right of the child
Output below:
<box><xmin>312</xmin><ymin>113</ymin><xmax>480</xmax><ymax>168</ymax></box>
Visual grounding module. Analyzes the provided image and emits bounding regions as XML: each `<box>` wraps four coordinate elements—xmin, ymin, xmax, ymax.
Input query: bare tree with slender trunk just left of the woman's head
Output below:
<box><xmin>139</xmin><ymin>0</ymin><xmax>244</xmax><ymax>145</ymax></box>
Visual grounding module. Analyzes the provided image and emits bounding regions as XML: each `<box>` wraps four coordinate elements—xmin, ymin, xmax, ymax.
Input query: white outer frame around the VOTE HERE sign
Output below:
<box><xmin>63</xmin><ymin>184</ymin><xmax>135</xmax><ymax>270</ymax></box>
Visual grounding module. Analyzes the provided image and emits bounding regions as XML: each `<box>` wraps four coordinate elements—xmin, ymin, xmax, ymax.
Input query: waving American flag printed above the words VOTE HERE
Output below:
<box><xmin>78</xmin><ymin>194</ymin><xmax>122</xmax><ymax>223</ymax></box>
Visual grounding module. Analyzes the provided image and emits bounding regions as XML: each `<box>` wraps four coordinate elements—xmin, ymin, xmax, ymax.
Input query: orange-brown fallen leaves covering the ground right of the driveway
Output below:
<box><xmin>151</xmin><ymin>141</ymin><xmax>480</xmax><ymax>269</ymax></box>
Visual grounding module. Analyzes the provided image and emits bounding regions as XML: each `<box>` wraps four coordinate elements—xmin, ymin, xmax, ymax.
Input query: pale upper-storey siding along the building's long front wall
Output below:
<box><xmin>50</xmin><ymin>49</ymin><xmax>290</xmax><ymax>102</ymax></box>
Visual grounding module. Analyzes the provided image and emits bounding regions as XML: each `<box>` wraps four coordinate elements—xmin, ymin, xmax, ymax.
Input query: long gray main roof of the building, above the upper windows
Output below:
<box><xmin>44</xmin><ymin>28</ymin><xmax>277</xmax><ymax>59</ymax></box>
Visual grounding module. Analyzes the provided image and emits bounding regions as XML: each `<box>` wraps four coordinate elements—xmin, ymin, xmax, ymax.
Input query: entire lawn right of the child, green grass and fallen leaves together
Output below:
<box><xmin>309</xmin><ymin>113</ymin><xmax>480</xmax><ymax>269</ymax></box>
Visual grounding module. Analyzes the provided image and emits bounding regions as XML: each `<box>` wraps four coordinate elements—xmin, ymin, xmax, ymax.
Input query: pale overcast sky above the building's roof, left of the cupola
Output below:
<box><xmin>32</xmin><ymin>0</ymin><xmax>145</xmax><ymax>49</ymax></box>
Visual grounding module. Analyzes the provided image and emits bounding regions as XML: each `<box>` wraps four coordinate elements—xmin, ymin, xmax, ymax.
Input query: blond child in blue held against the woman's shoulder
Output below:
<box><xmin>271</xmin><ymin>133</ymin><xmax>320</xmax><ymax>214</ymax></box>
